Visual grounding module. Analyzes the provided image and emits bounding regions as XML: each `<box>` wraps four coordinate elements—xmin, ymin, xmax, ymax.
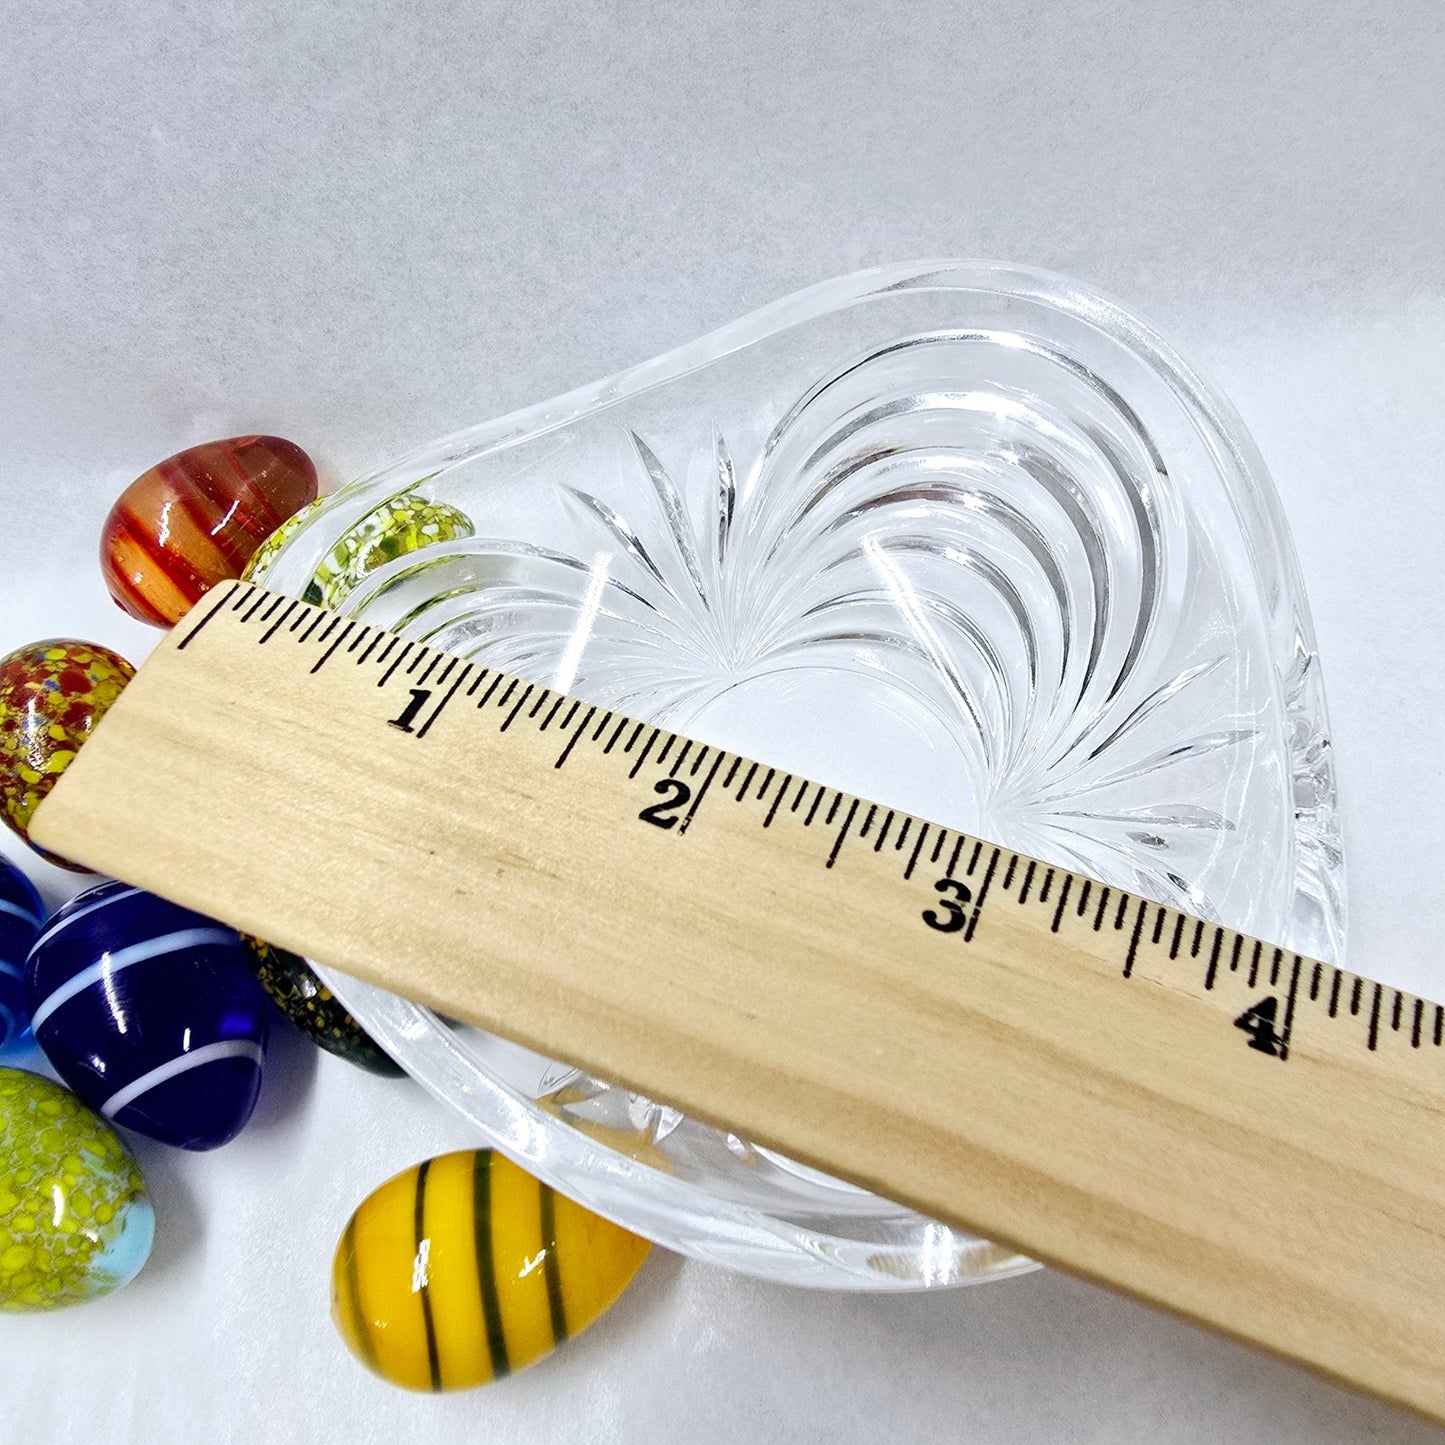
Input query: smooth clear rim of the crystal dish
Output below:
<box><xmin>302</xmin><ymin>260</ymin><xmax>1342</xmax><ymax>1292</ymax></box>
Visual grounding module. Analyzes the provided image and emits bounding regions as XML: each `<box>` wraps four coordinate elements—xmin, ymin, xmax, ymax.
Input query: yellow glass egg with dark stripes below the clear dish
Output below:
<box><xmin>331</xmin><ymin>1149</ymin><xmax>652</xmax><ymax>1390</ymax></box>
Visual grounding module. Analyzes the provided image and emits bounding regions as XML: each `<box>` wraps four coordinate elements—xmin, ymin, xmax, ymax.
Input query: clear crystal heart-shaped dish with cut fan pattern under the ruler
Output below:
<box><xmin>248</xmin><ymin>263</ymin><xmax>1344</xmax><ymax>1289</ymax></box>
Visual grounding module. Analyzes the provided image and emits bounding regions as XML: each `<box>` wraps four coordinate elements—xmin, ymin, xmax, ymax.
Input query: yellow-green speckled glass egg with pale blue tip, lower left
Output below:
<box><xmin>0</xmin><ymin>1068</ymin><xmax>156</xmax><ymax>1311</ymax></box>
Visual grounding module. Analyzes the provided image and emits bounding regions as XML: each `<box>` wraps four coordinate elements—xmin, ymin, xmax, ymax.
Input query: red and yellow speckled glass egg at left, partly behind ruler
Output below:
<box><xmin>0</xmin><ymin>637</ymin><xmax>136</xmax><ymax>873</ymax></box>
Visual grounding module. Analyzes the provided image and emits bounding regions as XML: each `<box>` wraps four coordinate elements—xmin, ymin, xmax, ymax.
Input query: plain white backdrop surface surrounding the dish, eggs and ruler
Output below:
<box><xmin>0</xmin><ymin>0</ymin><xmax>1445</xmax><ymax>1445</ymax></box>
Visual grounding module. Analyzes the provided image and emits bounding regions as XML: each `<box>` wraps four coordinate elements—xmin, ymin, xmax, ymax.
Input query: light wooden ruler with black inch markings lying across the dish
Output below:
<box><xmin>32</xmin><ymin>584</ymin><xmax>1445</xmax><ymax>1419</ymax></box>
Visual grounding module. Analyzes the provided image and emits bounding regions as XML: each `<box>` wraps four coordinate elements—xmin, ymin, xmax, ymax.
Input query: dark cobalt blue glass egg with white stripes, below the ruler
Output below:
<box><xmin>26</xmin><ymin>883</ymin><xmax>269</xmax><ymax>1149</ymax></box>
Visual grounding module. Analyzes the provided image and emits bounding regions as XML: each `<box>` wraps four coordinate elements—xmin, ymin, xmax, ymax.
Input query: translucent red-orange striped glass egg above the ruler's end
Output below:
<box><xmin>100</xmin><ymin>436</ymin><xmax>316</xmax><ymax>627</ymax></box>
